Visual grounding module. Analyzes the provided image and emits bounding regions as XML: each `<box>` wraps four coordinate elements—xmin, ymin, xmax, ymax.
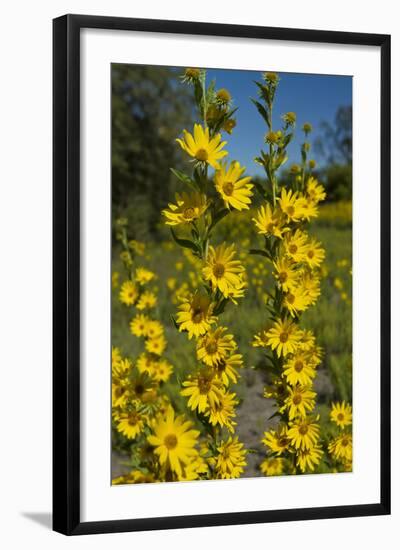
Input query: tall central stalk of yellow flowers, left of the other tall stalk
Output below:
<box><xmin>163</xmin><ymin>70</ymin><xmax>248</xmax><ymax>479</ymax></box>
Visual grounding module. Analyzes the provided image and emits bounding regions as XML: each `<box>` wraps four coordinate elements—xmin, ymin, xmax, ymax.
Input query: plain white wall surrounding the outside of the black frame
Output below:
<box><xmin>0</xmin><ymin>0</ymin><xmax>400</xmax><ymax>550</ymax></box>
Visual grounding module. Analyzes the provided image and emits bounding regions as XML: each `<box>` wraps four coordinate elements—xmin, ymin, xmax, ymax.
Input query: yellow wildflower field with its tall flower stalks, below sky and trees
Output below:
<box><xmin>111</xmin><ymin>69</ymin><xmax>352</xmax><ymax>484</ymax></box>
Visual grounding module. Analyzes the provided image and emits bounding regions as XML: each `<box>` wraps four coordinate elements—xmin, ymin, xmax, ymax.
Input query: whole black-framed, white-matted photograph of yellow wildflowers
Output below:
<box><xmin>53</xmin><ymin>15</ymin><xmax>390</xmax><ymax>535</ymax></box>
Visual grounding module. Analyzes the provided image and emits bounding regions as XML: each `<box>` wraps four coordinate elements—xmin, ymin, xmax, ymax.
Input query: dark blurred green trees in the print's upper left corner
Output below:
<box><xmin>111</xmin><ymin>64</ymin><xmax>193</xmax><ymax>238</ymax></box>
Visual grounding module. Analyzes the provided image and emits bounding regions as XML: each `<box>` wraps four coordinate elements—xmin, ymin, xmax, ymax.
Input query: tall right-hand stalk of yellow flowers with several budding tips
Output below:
<box><xmin>252</xmin><ymin>72</ymin><xmax>332</xmax><ymax>475</ymax></box>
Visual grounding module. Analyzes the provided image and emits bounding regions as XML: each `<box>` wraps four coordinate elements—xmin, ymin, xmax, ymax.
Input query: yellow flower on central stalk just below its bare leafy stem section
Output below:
<box><xmin>202</xmin><ymin>243</ymin><xmax>245</xmax><ymax>298</ymax></box>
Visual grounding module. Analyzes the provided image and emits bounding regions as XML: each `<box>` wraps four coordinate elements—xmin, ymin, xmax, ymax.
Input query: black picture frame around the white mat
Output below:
<box><xmin>53</xmin><ymin>15</ymin><xmax>390</xmax><ymax>535</ymax></box>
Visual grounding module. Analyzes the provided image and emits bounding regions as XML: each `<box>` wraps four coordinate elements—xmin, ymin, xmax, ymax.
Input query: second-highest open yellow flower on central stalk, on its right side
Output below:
<box><xmin>214</xmin><ymin>161</ymin><xmax>253</xmax><ymax>210</ymax></box>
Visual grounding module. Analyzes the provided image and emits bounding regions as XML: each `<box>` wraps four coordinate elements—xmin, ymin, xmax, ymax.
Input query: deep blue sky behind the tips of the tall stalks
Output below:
<box><xmin>207</xmin><ymin>69</ymin><xmax>352</xmax><ymax>175</ymax></box>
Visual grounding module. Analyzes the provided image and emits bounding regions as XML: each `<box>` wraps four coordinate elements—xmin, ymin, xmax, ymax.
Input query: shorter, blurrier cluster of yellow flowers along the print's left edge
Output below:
<box><xmin>112</xmin><ymin>223</ymin><xmax>208</xmax><ymax>485</ymax></box>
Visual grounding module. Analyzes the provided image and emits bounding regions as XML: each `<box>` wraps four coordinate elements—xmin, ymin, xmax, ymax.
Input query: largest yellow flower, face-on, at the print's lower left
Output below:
<box><xmin>147</xmin><ymin>407</ymin><xmax>200</xmax><ymax>476</ymax></box>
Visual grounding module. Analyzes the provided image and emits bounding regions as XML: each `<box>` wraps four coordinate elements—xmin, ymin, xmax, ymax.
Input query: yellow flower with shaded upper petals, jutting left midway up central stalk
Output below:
<box><xmin>176</xmin><ymin>293</ymin><xmax>216</xmax><ymax>339</ymax></box>
